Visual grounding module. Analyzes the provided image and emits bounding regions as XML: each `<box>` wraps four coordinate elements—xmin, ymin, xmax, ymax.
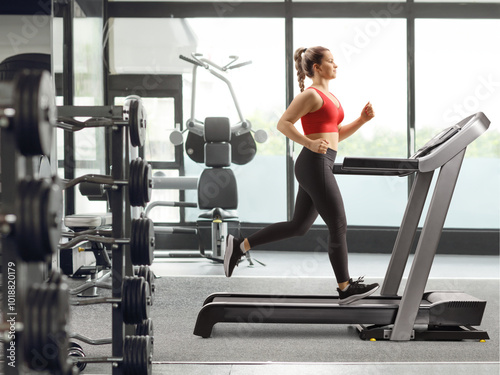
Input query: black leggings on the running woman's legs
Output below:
<box><xmin>248</xmin><ymin>147</ymin><xmax>349</xmax><ymax>283</ymax></box>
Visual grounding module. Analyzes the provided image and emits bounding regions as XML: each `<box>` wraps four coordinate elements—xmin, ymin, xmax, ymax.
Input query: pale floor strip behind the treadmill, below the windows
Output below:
<box><xmin>152</xmin><ymin>250</ymin><xmax>500</xmax><ymax>279</ymax></box>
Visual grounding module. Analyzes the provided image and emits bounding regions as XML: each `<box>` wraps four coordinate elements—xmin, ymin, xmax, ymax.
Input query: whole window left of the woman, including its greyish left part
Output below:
<box><xmin>110</xmin><ymin>18</ymin><xmax>286</xmax><ymax>222</ymax></box>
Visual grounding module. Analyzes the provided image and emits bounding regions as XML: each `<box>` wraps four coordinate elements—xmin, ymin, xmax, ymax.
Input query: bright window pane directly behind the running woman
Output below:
<box><xmin>294</xmin><ymin>18</ymin><xmax>407</xmax><ymax>226</ymax></box>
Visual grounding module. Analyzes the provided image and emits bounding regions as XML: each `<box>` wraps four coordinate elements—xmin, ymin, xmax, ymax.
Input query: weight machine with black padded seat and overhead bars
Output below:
<box><xmin>155</xmin><ymin>53</ymin><xmax>267</xmax><ymax>265</ymax></box>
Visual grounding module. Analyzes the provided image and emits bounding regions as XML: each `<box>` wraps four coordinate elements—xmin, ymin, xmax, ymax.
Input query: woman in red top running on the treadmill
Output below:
<box><xmin>224</xmin><ymin>47</ymin><xmax>379</xmax><ymax>304</ymax></box>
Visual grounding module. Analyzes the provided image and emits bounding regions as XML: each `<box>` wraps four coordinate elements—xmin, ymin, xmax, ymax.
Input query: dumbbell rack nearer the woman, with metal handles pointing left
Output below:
<box><xmin>58</xmin><ymin>100</ymin><xmax>154</xmax><ymax>375</ymax></box>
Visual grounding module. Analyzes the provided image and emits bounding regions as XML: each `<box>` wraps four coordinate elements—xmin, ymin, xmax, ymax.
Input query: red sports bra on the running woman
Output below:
<box><xmin>301</xmin><ymin>87</ymin><xmax>344</xmax><ymax>135</ymax></box>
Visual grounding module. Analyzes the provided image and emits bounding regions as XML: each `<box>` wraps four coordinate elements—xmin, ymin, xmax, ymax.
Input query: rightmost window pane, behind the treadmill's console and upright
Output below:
<box><xmin>415</xmin><ymin>19</ymin><xmax>500</xmax><ymax>228</ymax></box>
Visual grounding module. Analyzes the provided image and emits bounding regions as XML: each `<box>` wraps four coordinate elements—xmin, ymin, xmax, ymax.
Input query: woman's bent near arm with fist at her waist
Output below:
<box><xmin>277</xmin><ymin>90</ymin><xmax>329</xmax><ymax>154</ymax></box>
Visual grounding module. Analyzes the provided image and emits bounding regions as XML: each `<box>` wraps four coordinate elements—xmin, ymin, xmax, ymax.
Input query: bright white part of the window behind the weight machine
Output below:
<box><xmin>184</xmin><ymin>18</ymin><xmax>286</xmax><ymax>222</ymax></box>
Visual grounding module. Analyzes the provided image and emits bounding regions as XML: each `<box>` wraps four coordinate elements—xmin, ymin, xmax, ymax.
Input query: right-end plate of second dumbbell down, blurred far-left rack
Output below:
<box><xmin>40</xmin><ymin>182</ymin><xmax>63</xmax><ymax>255</ymax></box>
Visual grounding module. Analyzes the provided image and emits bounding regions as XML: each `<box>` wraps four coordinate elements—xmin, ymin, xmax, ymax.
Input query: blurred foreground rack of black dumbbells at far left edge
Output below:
<box><xmin>0</xmin><ymin>71</ymin><xmax>69</xmax><ymax>375</ymax></box>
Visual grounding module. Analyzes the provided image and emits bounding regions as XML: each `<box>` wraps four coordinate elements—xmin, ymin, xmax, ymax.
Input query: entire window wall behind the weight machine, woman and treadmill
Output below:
<box><xmin>106</xmin><ymin>0</ymin><xmax>500</xmax><ymax>232</ymax></box>
